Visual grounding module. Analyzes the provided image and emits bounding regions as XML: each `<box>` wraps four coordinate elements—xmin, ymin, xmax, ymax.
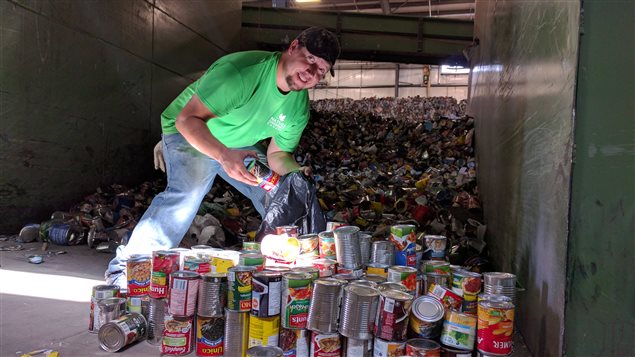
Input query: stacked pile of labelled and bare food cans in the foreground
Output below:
<box><xmin>89</xmin><ymin>222</ymin><xmax>516</xmax><ymax>357</ymax></box>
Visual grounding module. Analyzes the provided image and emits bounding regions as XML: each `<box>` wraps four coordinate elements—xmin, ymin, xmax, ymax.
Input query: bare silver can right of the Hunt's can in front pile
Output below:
<box><xmin>307</xmin><ymin>279</ymin><xmax>344</xmax><ymax>334</ymax></box>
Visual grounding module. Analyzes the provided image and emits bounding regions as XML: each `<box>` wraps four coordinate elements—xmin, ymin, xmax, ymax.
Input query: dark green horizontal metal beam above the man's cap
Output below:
<box><xmin>242</xmin><ymin>6</ymin><xmax>474</xmax><ymax>64</ymax></box>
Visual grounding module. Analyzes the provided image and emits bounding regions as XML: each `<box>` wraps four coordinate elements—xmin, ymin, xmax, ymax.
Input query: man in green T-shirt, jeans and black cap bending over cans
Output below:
<box><xmin>106</xmin><ymin>27</ymin><xmax>340</xmax><ymax>288</ymax></box>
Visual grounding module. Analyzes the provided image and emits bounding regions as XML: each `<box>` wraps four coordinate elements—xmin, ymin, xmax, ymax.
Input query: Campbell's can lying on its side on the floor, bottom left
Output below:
<box><xmin>98</xmin><ymin>313</ymin><xmax>148</xmax><ymax>352</ymax></box>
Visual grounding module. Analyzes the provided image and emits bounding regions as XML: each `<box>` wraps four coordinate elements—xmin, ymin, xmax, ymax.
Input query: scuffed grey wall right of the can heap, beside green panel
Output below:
<box><xmin>469</xmin><ymin>0</ymin><xmax>580</xmax><ymax>357</ymax></box>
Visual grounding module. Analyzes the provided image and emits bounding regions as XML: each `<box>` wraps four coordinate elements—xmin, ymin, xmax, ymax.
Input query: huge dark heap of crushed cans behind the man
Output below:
<box><xmin>8</xmin><ymin>97</ymin><xmax>487</xmax><ymax>271</ymax></box>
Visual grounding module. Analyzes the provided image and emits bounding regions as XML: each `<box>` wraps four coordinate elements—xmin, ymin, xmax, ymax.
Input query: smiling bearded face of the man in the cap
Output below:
<box><xmin>277</xmin><ymin>40</ymin><xmax>331</xmax><ymax>92</ymax></box>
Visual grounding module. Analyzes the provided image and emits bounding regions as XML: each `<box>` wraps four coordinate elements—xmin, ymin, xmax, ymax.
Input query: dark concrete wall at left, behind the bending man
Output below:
<box><xmin>0</xmin><ymin>0</ymin><xmax>241</xmax><ymax>234</ymax></box>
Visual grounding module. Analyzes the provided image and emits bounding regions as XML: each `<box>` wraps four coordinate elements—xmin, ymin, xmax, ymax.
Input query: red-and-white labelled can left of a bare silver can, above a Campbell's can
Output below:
<box><xmin>168</xmin><ymin>270</ymin><xmax>200</xmax><ymax>316</ymax></box>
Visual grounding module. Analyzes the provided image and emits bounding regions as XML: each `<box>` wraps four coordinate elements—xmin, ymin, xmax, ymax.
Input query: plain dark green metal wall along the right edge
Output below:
<box><xmin>565</xmin><ymin>0</ymin><xmax>635</xmax><ymax>357</ymax></box>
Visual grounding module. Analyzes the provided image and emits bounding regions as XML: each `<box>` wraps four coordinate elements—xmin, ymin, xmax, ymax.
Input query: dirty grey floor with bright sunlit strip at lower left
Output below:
<box><xmin>0</xmin><ymin>240</ymin><xmax>531</xmax><ymax>357</ymax></box>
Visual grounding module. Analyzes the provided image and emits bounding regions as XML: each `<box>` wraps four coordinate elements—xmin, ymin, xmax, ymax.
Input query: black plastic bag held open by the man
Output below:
<box><xmin>256</xmin><ymin>172</ymin><xmax>326</xmax><ymax>242</ymax></box>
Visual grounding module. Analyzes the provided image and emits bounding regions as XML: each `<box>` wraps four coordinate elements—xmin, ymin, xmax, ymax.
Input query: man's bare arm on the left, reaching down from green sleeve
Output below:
<box><xmin>176</xmin><ymin>94</ymin><xmax>260</xmax><ymax>186</ymax></box>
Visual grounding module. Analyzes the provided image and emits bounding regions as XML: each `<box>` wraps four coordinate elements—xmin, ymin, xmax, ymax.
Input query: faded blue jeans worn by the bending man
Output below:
<box><xmin>106</xmin><ymin>133</ymin><xmax>266</xmax><ymax>276</ymax></box>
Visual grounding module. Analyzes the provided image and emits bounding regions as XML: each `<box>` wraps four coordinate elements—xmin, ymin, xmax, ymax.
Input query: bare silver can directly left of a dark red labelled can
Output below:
<box><xmin>338</xmin><ymin>285</ymin><xmax>379</xmax><ymax>340</ymax></box>
